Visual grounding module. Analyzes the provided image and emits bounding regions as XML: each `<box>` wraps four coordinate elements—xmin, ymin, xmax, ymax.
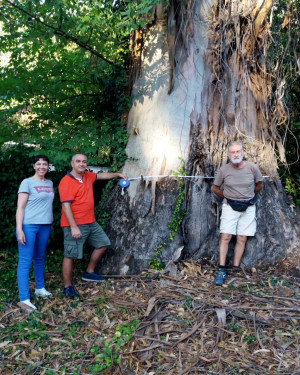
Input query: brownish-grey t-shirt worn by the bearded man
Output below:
<box><xmin>214</xmin><ymin>161</ymin><xmax>263</xmax><ymax>201</ymax></box>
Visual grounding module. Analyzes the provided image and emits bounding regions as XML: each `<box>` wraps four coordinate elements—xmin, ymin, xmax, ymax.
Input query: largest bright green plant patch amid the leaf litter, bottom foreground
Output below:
<box><xmin>88</xmin><ymin>319</ymin><xmax>140</xmax><ymax>374</ymax></box>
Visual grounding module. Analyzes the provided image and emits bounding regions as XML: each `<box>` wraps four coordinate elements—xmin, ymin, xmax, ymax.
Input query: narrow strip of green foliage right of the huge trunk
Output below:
<box><xmin>268</xmin><ymin>0</ymin><xmax>300</xmax><ymax>205</ymax></box>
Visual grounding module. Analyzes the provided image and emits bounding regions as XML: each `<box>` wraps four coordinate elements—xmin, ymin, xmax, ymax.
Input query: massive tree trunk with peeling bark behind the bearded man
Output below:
<box><xmin>100</xmin><ymin>0</ymin><xmax>298</xmax><ymax>274</ymax></box>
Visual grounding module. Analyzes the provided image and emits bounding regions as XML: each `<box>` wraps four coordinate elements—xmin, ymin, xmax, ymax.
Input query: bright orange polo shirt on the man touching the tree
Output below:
<box><xmin>58</xmin><ymin>172</ymin><xmax>97</xmax><ymax>227</ymax></box>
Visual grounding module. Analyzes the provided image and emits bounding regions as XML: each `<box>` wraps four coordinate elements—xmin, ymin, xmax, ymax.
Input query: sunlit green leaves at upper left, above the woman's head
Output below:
<box><xmin>0</xmin><ymin>0</ymin><xmax>158</xmax><ymax>170</ymax></box>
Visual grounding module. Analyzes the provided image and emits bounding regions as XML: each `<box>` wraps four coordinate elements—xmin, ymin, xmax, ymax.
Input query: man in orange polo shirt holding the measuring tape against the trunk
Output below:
<box><xmin>58</xmin><ymin>154</ymin><xmax>126</xmax><ymax>298</ymax></box>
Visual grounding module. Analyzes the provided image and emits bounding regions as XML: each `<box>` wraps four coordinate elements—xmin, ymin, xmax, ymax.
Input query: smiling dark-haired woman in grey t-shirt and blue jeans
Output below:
<box><xmin>16</xmin><ymin>155</ymin><xmax>54</xmax><ymax>310</ymax></box>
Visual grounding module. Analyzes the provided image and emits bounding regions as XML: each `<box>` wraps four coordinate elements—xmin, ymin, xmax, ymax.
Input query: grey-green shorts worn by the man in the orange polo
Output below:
<box><xmin>62</xmin><ymin>221</ymin><xmax>110</xmax><ymax>259</ymax></box>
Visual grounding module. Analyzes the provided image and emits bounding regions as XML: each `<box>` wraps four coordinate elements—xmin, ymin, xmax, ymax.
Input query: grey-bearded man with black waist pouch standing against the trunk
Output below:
<box><xmin>212</xmin><ymin>142</ymin><xmax>264</xmax><ymax>285</ymax></box>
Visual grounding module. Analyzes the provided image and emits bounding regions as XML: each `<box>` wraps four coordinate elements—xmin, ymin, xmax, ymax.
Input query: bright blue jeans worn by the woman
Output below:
<box><xmin>17</xmin><ymin>224</ymin><xmax>51</xmax><ymax>301</ymax></box>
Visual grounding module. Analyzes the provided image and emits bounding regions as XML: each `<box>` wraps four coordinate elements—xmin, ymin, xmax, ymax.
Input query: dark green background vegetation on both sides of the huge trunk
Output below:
<box><xmin>0</xmin><ymin>0</ymin><xmax>300</xmax><ymax>302</ymax></box>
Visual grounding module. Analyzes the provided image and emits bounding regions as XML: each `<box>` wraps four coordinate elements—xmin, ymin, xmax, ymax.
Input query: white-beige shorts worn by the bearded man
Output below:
<box><xmin>220</xmin><ymin>204</ymin><xmax>256</xmax><ymax>236</ymax></box>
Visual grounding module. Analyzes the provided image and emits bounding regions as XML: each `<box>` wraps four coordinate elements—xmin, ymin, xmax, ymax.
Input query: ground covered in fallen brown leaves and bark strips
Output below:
<box><xmin>0</xmin><ymin>261</ymin><xmax>300</xmax><ymax>375</ymax></box>
